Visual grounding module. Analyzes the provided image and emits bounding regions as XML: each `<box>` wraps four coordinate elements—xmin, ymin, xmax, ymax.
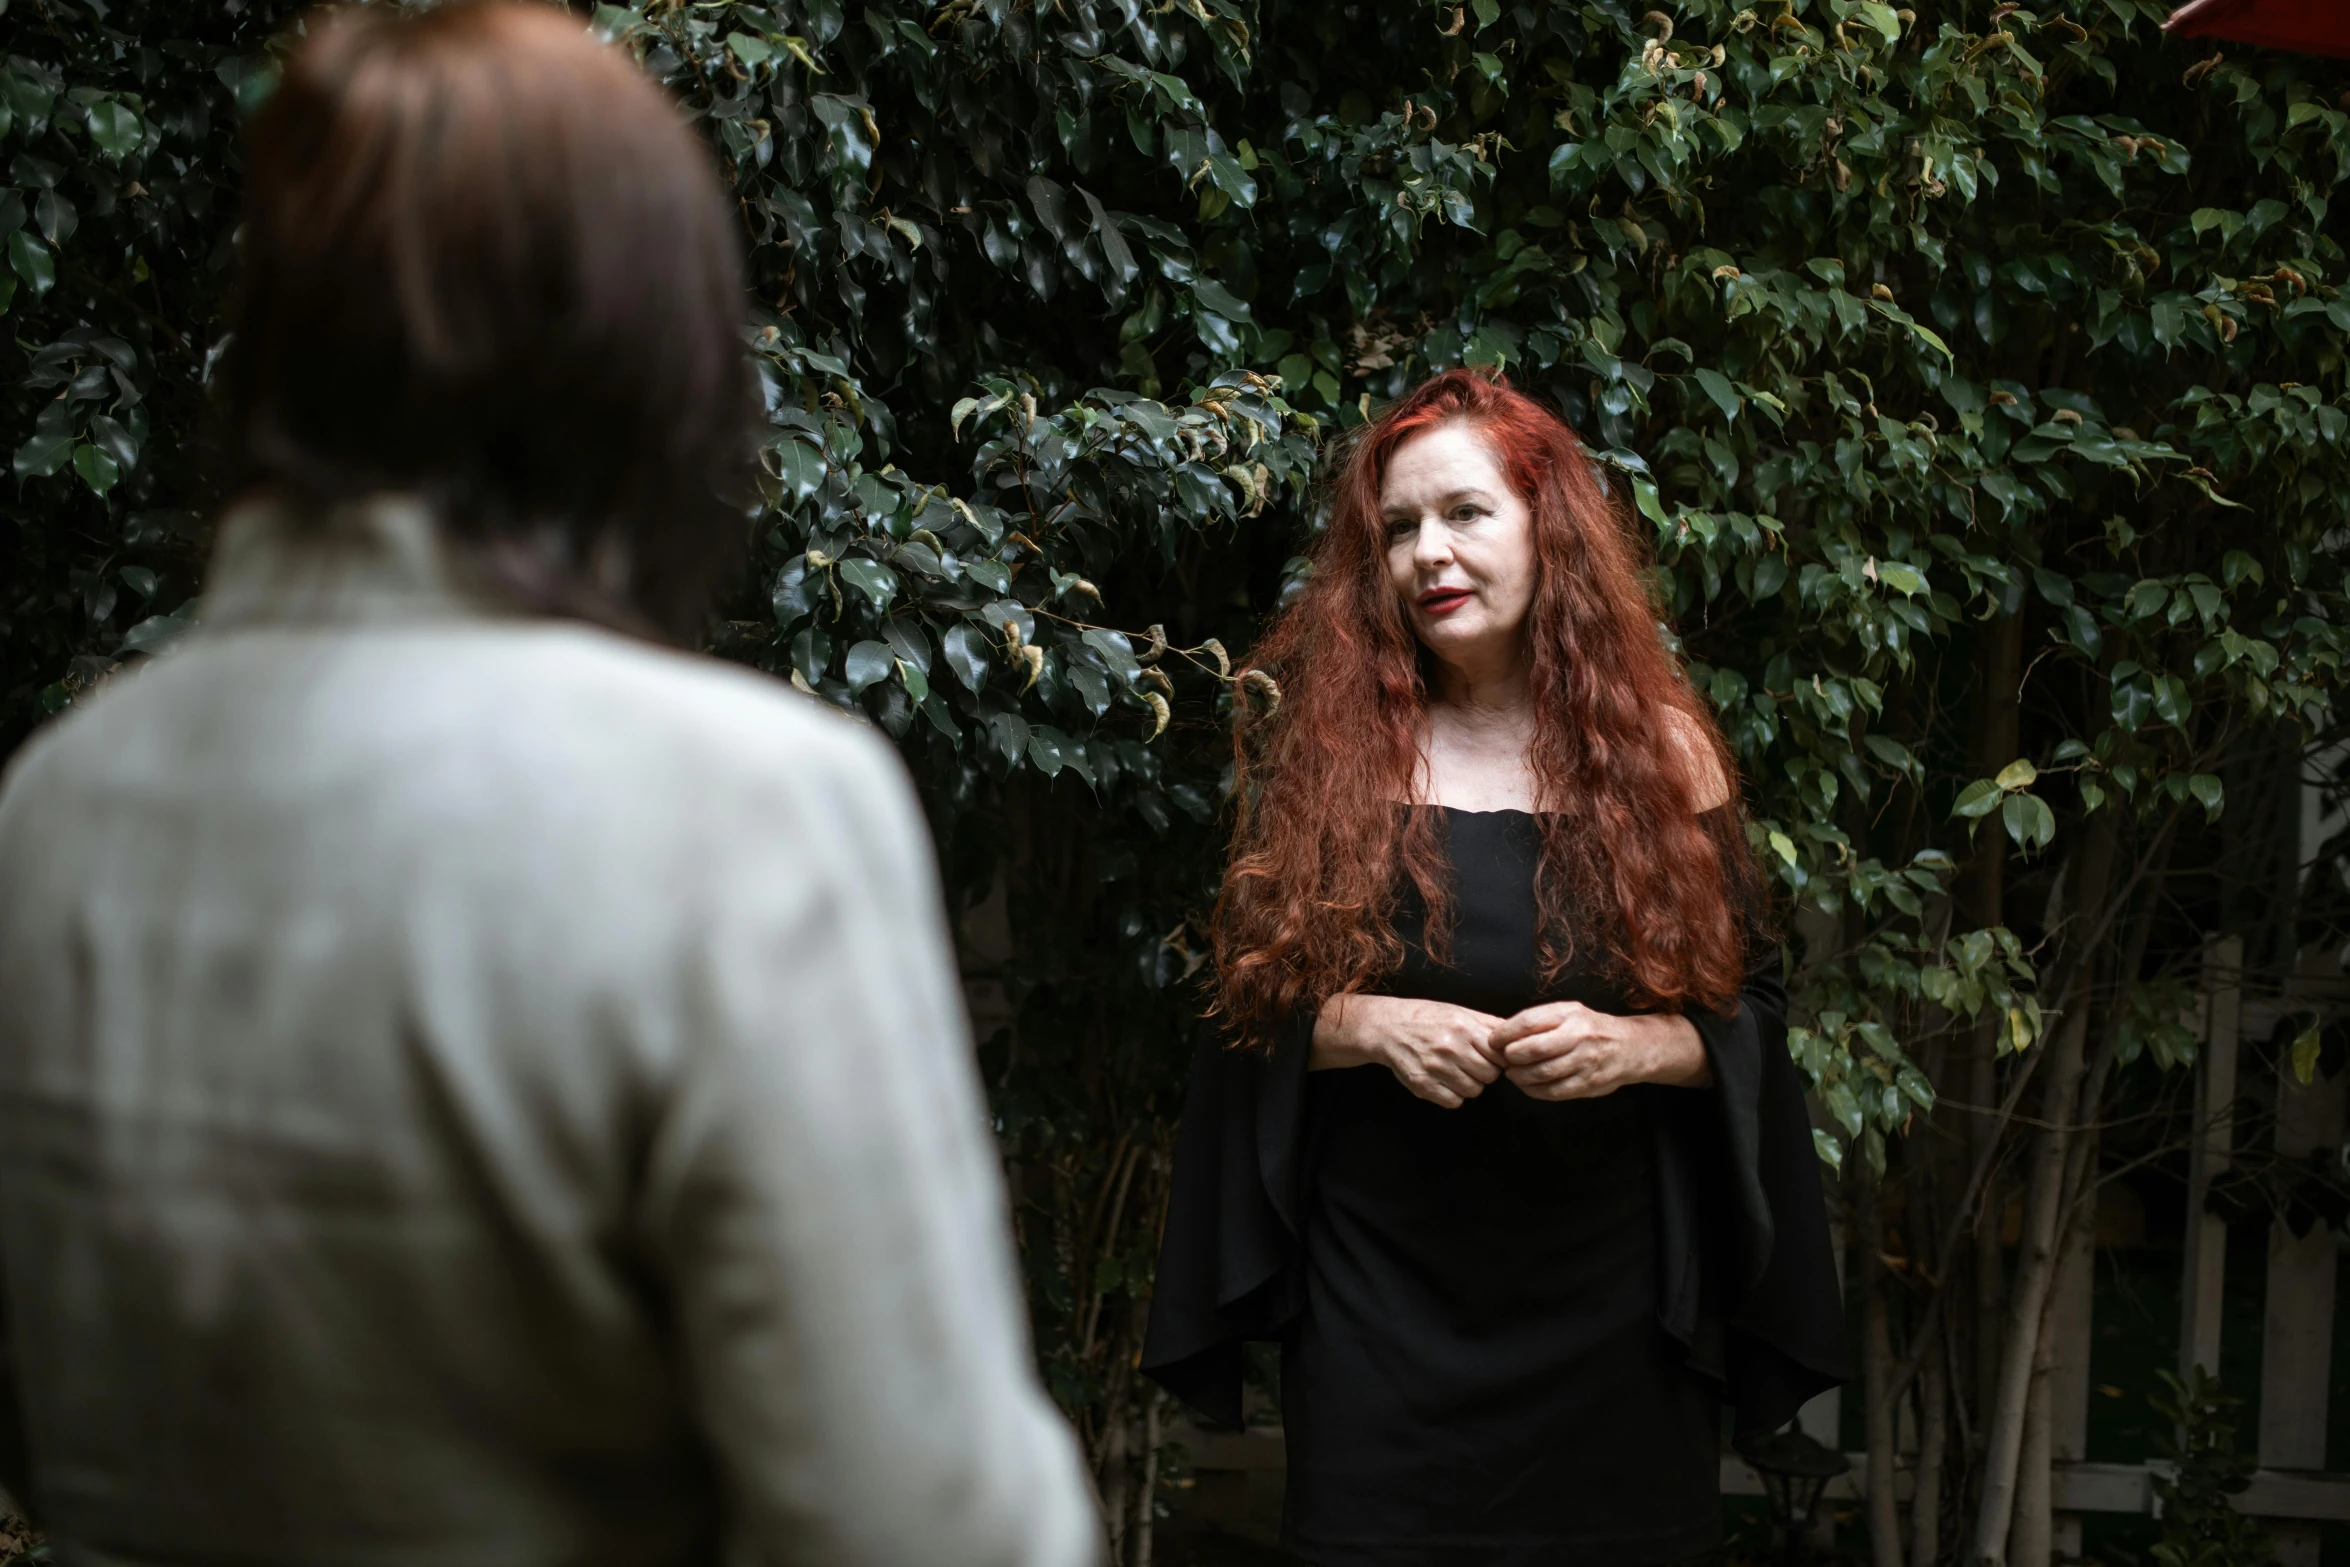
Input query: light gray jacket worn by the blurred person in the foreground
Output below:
<box><xmin>0</xmin><ymin>503</ymin><xmax>1095</xmax><ymax>1567</ymax></box>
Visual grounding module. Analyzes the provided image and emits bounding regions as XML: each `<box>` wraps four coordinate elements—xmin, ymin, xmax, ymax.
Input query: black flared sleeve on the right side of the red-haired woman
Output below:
<box><xmin>1657</xmin><ymin>947</ymin><xmax>1852</xmax><ymax>1431</ymax></box>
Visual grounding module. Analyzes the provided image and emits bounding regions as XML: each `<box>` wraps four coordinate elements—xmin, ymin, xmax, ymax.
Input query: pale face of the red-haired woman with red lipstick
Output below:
<box><xmin>1379</xmin><ymin>421</ymin><xmax>1535</xmax><ymax>667</ymax></box>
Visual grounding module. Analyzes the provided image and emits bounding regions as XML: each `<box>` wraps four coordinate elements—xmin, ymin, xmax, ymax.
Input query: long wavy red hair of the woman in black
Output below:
<box><xmin>1215</xmin><ymin>371</ymin><xmax>1751</xmax><ymax>1043</ymax></box>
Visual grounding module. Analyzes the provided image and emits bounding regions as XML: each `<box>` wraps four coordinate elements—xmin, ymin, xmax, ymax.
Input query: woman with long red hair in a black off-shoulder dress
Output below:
<box><xmin>1144</xmin><ymin>371</ymin><xmax>1845</xmax><ymax>1567</ymax></box>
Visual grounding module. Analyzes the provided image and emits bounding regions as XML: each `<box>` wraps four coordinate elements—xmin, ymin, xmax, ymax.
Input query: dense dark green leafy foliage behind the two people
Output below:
<box><xmin>13</xmin><ymin>0</ymin><xmax>2350</xmax><ymax>1560</ymax></box>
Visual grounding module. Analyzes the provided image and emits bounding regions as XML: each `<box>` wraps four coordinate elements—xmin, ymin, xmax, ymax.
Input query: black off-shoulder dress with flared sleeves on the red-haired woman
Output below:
<box><xmin>1142</xmin><ymin>811</ymin><xmax>1847</xmax><ymax>1567</ymax></box>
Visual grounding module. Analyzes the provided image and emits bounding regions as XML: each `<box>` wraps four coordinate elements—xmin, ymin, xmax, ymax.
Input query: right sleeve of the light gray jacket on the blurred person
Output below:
<box><xmin>644</xmin><ymin>735</ymin><xmax>1100</xmax><ymax>1567</ymax></box>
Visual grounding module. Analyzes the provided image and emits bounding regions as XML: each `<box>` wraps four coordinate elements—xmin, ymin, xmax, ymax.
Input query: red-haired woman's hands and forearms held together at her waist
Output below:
<box><xmin>1307</xmin><ymin>994</ymin><xmax>1713</xmax><ymax>1109</ymax></box>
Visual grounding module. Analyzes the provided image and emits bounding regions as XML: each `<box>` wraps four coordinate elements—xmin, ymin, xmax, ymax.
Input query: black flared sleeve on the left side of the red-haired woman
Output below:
<box><xmin>1142</xmin><ymin>1010</ymin><xmax>1314</xmax><ymax>1426</ymax></box>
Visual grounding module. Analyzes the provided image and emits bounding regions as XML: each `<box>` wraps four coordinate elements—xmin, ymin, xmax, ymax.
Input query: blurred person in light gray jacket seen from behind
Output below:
<box><xmin>0</xmin><ymin>2</ymin><xmax>1095</xmax><ymax>1567</ymax></box>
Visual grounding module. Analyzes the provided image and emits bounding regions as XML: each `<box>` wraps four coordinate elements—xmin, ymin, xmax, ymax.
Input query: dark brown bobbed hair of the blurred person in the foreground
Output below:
<box><xmin>221</xmin><ymin>0</ymin><xmax>752</xmax><ymax>637</ymax></box>
